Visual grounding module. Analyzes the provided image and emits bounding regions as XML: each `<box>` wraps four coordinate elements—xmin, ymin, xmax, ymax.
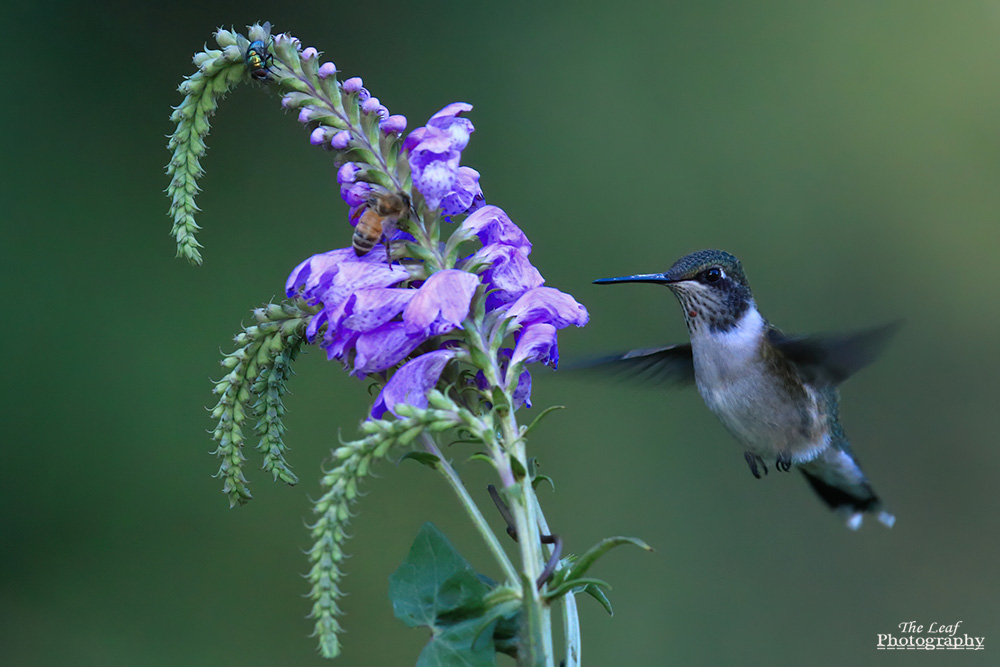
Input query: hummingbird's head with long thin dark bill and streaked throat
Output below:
<box><xmin>594</xmin><ymin>250</ymin><xmax>753</xmax><ymax>334</ymax></box>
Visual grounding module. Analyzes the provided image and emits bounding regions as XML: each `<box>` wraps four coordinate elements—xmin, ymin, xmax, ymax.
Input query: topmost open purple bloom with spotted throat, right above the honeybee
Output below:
<box><xmin>403</xmin><ymin>102</ymin><xmax>478</xmax><ymax>210</ymax></box>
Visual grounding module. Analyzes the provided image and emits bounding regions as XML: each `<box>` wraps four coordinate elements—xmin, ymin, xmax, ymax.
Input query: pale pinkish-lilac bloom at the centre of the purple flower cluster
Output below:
<box><xmin>403</xmin><ymin>269</ymin><xmax>479</xmax><ymax>337</ymax></box>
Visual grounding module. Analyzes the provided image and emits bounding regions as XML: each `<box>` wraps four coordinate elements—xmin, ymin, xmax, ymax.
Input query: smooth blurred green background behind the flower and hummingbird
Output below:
<box><xmin>0</xmin><ymin>0</ymin><xmax>1000</xmax><ymax>666</ymax></box>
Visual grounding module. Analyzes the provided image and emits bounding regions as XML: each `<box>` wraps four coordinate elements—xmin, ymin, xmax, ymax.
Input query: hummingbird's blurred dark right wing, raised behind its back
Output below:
<box><xmin>767</xmin><ymin>321</ymin><xmax>901</xmax><ymax>386</ymax></box>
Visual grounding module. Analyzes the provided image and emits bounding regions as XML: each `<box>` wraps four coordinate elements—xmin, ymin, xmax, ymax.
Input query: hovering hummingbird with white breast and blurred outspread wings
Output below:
<box><xmin>594</xmin><ymin>250</ymin><xmax>897</xmax><ymax>530</ymax></box>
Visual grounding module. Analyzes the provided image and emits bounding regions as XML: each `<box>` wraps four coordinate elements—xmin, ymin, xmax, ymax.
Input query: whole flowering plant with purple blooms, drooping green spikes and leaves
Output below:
<box><xmin>167</xmin><ymin>24</ymin><xmax>648</xmax><ymax>666</ymax></box>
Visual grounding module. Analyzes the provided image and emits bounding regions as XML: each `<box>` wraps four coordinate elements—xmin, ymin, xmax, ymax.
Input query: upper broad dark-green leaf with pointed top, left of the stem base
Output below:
<box><xmin>389</xmin><ymin>523</ymin><xmax>489</xmax><ymax>636</ymax></box>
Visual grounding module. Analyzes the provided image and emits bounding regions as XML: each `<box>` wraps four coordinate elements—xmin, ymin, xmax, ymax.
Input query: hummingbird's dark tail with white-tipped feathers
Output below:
<box><xmin>799</xmin><ymin>447</ymin><xmax>896</xmax><ymax>530</ymax></box>
